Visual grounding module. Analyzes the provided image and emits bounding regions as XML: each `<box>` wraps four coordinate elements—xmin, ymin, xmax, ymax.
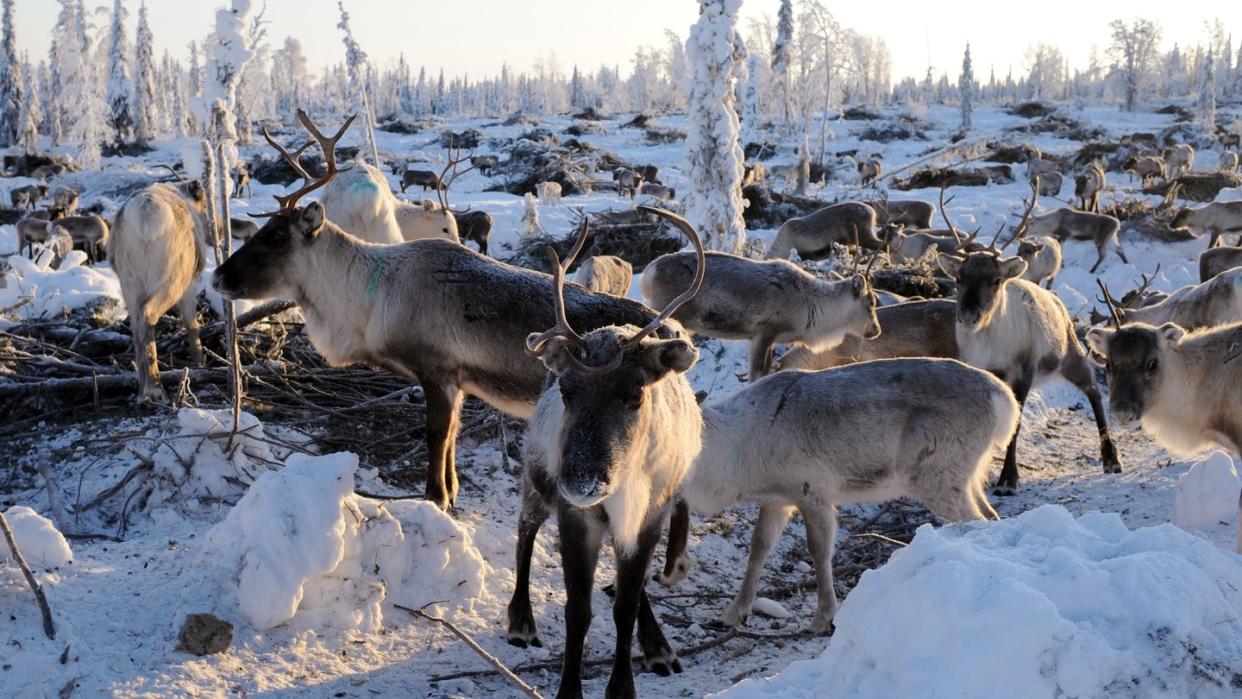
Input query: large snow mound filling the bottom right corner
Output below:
<box><xmin>723</xmin><ymin>505</ymin><xmax>1242</xmax><ymax>698</ymax></box>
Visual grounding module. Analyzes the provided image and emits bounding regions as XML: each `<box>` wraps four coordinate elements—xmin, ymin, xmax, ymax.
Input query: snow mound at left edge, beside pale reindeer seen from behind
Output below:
<box><xmin>0</xmin><ymin>251</ymin><xmax>125</xmax><ymax>323</ymax></box>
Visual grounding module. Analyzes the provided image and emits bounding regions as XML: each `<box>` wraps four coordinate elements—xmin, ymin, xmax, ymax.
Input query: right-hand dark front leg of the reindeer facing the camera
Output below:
<box><xmin>606</xmin><ymin>516</ymin><xmax>676</xmax><ymax>698</ymax></box>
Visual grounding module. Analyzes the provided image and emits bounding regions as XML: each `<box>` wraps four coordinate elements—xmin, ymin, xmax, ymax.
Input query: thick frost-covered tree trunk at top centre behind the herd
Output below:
<box><xmin>686</xmin><ymin>0</ymin><xmax>746</xmax><ymax>253</ymax></box>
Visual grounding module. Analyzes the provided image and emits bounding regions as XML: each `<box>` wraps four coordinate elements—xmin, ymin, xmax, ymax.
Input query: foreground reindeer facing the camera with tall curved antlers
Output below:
<box><xmin>508</xmin><ymin>214</ymin><xmax>704</xmax><ymax>697</ymax></box>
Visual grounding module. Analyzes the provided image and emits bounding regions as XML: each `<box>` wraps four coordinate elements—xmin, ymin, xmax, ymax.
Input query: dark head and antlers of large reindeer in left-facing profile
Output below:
<box><xmin>211</xmin><ymin>109</ymin><xmax>354</xmax><ymax>298</ymax></box>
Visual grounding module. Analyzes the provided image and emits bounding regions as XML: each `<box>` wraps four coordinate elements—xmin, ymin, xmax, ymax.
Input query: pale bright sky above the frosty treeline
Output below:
<box><xmin>9</xmin><ymin>0</ymin><xmax>1242</xmax><ymax>82</ymax></box>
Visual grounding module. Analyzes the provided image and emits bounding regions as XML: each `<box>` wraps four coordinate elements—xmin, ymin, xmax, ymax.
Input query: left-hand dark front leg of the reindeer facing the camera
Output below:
<box><xmin>556</xmin><ymin>500</ymin><xmax>606</xmax><ymax>699</ymax></box>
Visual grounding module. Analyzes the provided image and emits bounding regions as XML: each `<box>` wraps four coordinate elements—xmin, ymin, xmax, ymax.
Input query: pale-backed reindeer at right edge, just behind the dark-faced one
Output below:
<box><xmin>1104</xmin><ymin>268</ymin><xmax>1242</xmax><ymax>330</ymax></box>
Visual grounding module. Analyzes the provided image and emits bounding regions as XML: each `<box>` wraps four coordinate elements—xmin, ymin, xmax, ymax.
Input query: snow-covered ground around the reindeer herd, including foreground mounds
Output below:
<box><xmin>0</xmin><ymin>101</ymin><xmax>1242</xmax><ymax>697</ymax></box>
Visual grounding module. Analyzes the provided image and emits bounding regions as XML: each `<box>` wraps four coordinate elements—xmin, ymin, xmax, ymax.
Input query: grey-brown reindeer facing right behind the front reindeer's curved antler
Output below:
<box><xmin>642</xmin><ymin>252</ymin><xmax>881</xmax><ymax>381</ymax></box>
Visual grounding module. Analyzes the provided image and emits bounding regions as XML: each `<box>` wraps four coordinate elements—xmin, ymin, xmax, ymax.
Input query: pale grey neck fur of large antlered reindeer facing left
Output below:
<box><xmin>291</xmin><ymin>222</ymin><xmax>389</xmax><ymax>365</ymax></box>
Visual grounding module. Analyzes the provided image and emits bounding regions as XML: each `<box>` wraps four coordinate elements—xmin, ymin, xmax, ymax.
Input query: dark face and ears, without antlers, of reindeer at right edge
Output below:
<box><xmin>1087</xmin><ymin>323</ymin><xmax>1186</xmax><ymax>425</ymax></box>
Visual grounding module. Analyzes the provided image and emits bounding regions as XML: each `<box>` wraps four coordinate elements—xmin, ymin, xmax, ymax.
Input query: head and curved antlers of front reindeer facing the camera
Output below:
<box><xmin>527</xmin><ymin>207</ymin><xmax>705</xmax><ymax>508</ymax></box>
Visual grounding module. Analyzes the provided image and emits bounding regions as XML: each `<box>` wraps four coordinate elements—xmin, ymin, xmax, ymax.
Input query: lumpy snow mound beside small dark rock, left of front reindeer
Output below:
<box><xmin>204</xmin><ymin>453</ymin><xmax>491</xmax><ymax>633</ymax></box>
